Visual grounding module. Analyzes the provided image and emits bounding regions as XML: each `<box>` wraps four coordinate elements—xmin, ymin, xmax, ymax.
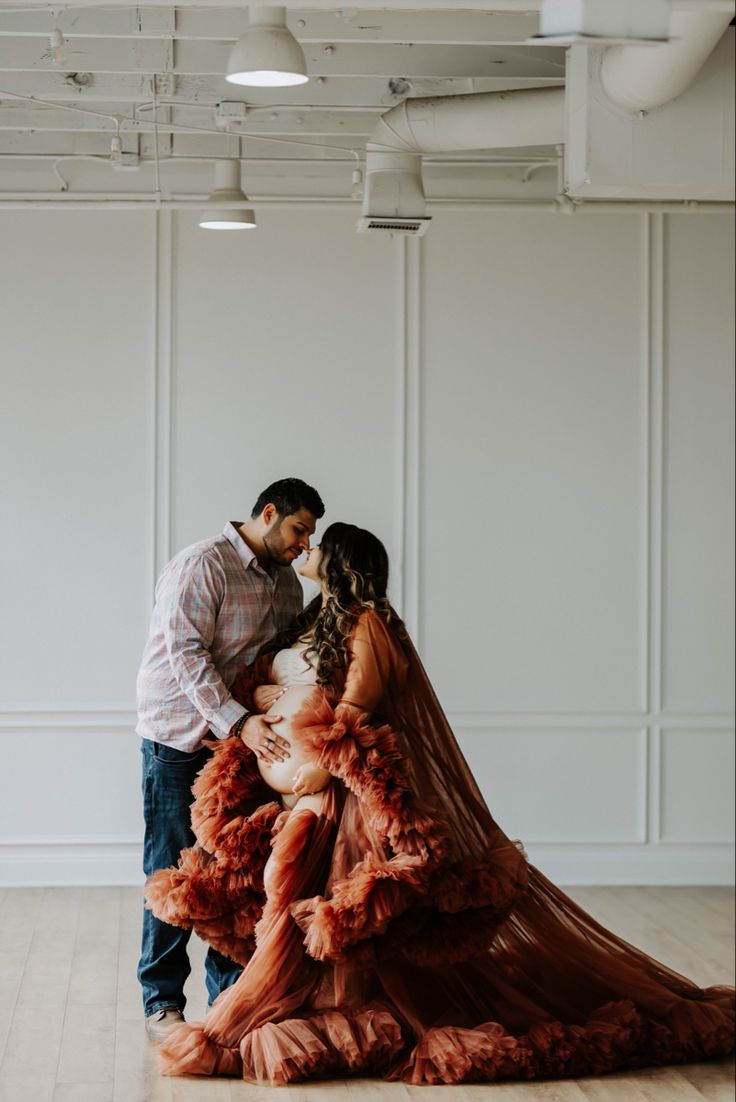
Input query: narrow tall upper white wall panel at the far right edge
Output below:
<box><xmin>662</xmin><ymin>215</ymin><xmax>735</xmax><ymax>713</ymax></box>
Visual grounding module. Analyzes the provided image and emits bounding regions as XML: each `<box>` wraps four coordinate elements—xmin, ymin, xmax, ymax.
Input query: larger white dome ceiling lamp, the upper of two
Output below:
<box><xmin>225</xmin><ymin>4</ymin><xmax>310</xmax><ymax>88</ymax></box>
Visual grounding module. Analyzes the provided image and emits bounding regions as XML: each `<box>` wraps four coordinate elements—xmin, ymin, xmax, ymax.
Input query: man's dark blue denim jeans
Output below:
<box><xmin>138</xmin><ymin>738</ymin><xmax>242</xmax><ymax>1017</ymax></box>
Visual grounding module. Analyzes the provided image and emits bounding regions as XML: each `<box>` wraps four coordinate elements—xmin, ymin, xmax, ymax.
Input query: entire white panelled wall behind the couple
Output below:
<box><xmin>0</xmin><ymin>205</ymin><xmax>734</xmax><ymax>884</ymax></box>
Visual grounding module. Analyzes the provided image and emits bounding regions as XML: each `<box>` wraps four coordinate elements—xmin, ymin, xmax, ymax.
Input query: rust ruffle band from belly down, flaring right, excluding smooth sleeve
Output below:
<box><xmin>290</xmin><ymin>698</ymin><xmax>527</xmax><ymax>965</ymax></box>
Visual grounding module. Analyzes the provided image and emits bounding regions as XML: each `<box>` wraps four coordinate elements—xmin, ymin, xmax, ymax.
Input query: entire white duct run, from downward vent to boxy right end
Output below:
<box><xmin>358</xmin><ymin>8</ymin><xmax>733</xmax><ymax>234</ymax></box>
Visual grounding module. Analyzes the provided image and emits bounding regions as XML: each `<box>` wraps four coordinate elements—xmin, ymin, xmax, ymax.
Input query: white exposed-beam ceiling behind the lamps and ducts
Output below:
<box><xmin>0</xmin><ymin>0</ymin><xmax>727</xmax><ymax>196</ymax></box>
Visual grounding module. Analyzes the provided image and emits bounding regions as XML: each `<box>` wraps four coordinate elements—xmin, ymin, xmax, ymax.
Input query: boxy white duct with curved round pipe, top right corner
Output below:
<box><xmin>564</xmin><ymin>11</ymin><xmax>736</xmax><ymax>203</ymax></box>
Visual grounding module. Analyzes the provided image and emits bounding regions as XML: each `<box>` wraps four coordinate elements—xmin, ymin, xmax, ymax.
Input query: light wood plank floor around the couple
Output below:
<box><xmin>0</xmin><ymin>887</ymin><xmax>734</xmax><ymax>1102</ymax></box>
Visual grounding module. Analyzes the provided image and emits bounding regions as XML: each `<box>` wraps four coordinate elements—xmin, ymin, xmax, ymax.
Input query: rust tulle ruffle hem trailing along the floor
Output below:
<box><xmin>162</xmin><ymin>987</ymin><xmax>734</xmax><ymax>1087</ymax></box>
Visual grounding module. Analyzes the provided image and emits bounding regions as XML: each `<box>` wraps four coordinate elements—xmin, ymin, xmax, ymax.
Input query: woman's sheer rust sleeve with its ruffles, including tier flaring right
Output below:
<box><xmin>291</xmin><ymin>612</ymin><xmax>526</xmax><ymax>963</ymax></box>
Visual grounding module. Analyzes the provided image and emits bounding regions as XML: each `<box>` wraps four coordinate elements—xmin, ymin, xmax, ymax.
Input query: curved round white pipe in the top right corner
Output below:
<box><xmin>600</xmin><ymin>11</ymin><xmax>733</xmax><ymax>112</ymax></box>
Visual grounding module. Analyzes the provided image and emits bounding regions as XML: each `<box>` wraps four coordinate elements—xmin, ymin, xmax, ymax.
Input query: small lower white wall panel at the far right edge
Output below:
<box><xmin>660</xmin><ymin>730</ymin><xmax>735</xmax><ymax>843</ymax></box>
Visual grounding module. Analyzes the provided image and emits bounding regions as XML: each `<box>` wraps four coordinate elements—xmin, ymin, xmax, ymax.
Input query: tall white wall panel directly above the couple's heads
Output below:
<box><xmin>173</xmin><ymin>210</ymin><xmax>402</xmax><ymax>581</ymax></box>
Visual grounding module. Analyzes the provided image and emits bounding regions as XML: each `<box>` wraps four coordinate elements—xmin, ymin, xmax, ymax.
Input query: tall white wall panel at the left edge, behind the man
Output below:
<box><xmin>0</xmin><ymin>210</ymin><xmax>153</xmax><ymax>709</ymax></box>
